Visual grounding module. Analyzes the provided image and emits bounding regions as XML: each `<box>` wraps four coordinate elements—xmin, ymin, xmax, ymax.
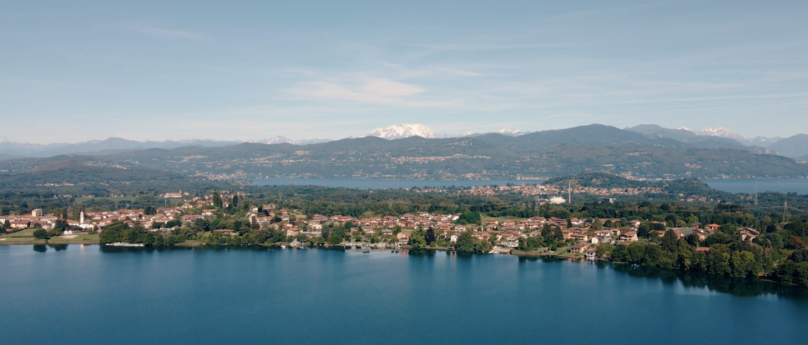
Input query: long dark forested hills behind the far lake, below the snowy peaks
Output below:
<box><xmin>0</xmin><ymin>125</ymin><xmax>808</xmax><ymax>179</ymax></box>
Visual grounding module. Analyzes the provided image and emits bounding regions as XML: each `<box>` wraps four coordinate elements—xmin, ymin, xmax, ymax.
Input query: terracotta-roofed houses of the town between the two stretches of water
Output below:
<box><xmin>0</xmin><ymin>185</ymin><xmax>760</xmax><ymax>260</ymax></box>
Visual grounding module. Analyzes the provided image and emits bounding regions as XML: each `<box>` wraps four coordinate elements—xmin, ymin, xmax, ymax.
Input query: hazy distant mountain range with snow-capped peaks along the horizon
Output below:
<box><xmin>0</xmin><ymin>124</ymin><xmax>808</xmax><ymax>168</ymax></box>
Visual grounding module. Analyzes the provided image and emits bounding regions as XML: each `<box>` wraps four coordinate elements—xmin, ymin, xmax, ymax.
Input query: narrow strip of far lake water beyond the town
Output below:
<box><xmin>252</xmin><ymin>178</ymin><xmax>808</xmax><ymax>194</ymax></box>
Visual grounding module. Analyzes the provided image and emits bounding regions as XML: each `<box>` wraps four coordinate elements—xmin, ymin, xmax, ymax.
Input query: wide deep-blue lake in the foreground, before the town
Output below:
<box><xmin>0</xmin><ymin>245</ymin><xmax>808</xmax><ymax>345</ymax></box>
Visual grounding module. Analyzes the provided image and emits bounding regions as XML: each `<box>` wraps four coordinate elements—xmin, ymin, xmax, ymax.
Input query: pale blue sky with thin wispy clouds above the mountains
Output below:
<box><xmin>0</xmin><ymin>0</ymin><xmax>808</xmax><ymax>143</ymax></box>
